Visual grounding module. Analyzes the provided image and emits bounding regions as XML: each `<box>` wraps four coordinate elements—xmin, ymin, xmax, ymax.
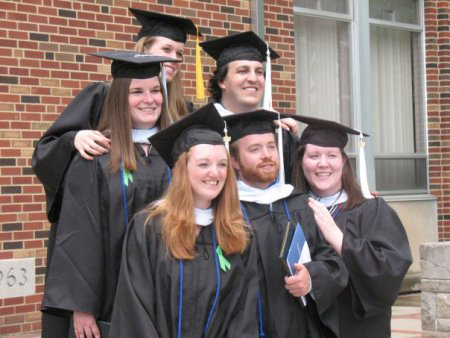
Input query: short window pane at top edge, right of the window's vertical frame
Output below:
<box><xmin>369</xmin><ymin>0</ymin><xmax>419</xmax><ymax>24</ymax></box>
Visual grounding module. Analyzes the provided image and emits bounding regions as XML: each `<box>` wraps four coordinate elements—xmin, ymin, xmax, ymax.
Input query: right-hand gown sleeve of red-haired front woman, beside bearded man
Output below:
<box><xmin>227</xmin><ymin>232</ymin><xmax>258</xmax><ymax>338</ymax></box>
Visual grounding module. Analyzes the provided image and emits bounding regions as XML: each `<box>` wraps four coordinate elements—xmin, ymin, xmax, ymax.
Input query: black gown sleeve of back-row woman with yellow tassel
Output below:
<box><xmin>32</xmin><ymin>83</ymin><xmax>109</xmax><ymax>222</ymax></box>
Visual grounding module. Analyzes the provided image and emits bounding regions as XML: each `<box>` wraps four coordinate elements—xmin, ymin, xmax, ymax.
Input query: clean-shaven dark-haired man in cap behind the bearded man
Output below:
<box><xmin>200</xmin><ymin>31</ymin><xmax>298</xmax><ymax>183</ymax></box>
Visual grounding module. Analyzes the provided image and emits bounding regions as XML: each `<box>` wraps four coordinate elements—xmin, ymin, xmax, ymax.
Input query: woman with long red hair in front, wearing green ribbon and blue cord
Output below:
<box><xmin>111</xmin><ymin>105</ymin><xmax>258</xmax><ymax>338</ymax></box>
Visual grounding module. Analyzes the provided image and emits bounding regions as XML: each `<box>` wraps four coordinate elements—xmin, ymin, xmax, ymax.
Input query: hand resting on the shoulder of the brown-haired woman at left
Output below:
<box><xmin>74</xmin><ymin>130</ymin><xmax>111</xmax><ymax>160</ymax></box>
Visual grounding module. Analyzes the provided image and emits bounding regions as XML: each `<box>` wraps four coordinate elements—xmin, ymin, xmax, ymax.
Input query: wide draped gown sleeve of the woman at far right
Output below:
<box><xmin>342</xmin><ymin>198</ymin><xmax>412</xmax><ymax>319</ymax></box>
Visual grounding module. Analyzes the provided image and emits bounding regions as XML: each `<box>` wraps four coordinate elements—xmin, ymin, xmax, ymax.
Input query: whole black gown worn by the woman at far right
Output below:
<box><xmin>335</xmin><ymin>198</ymin><xmax>412</xmax><ymax>338</ymax></box>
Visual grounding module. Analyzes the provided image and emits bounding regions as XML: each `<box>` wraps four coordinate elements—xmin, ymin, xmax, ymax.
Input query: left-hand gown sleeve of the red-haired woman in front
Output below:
<box><xmin>110</xmin><ymin>214</ymin><xmax>159</xmax><ymax>338</ymax></box>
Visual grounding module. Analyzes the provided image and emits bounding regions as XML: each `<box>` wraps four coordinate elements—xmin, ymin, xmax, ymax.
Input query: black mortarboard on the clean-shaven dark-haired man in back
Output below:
<box><xmin>200</xmin><ymin>31</ymin><xmax>280</xmax><ymax>68</ymax></box>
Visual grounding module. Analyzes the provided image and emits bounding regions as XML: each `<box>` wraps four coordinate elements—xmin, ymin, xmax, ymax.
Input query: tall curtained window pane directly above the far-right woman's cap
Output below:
<box><xmin>295</xmin><ymin>16</ymin><xmax>352</xmax><ymax>143</ymax></box>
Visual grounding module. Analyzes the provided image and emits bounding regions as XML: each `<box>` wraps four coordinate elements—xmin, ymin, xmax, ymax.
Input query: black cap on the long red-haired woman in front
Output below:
<box><xmin>149</xmin><ymin>103</ymin><xmax>225</xmax><ymax>168</ymax></box>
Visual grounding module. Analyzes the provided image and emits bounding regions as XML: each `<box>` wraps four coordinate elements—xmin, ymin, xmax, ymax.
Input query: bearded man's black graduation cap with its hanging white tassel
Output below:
<box><xmin>222</xmin><ymin>109</ymin><xmax>290</xmax><ymax>188</ymax></box>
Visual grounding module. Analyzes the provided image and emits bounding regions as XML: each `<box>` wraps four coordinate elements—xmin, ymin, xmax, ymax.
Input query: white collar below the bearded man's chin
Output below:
<box><xmin>238</xmin><ymin>180</ymin><xmax>294</xmax><ymax>204</ymax></box>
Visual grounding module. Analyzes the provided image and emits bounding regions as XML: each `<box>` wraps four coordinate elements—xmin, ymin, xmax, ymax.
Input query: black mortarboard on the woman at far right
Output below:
<box><xmin>291</xmin><ymin>115</ymin><xmax>369</xmax><ymax>149</ymax></box>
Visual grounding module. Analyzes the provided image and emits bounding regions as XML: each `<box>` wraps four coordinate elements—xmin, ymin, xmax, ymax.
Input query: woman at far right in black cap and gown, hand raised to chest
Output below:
<box><xmin>294</xmin><ymin>116</ymin><xmax>412</xmax><ymax>338</ymax></box>
